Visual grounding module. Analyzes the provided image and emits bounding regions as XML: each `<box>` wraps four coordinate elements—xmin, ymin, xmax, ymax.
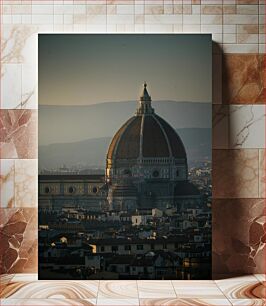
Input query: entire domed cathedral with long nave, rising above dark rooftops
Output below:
<box><xmin>39</xmin><ymin>83</ymin><xmax>201</xmax><ymax>211</ymax></box>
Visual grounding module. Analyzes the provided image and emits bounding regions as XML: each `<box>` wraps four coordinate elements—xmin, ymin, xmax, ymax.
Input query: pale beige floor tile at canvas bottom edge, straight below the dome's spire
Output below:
<box><xmin>137</xmin><ymin>280</ymin><xmax>176</xmax><ymax>299</ymax></box>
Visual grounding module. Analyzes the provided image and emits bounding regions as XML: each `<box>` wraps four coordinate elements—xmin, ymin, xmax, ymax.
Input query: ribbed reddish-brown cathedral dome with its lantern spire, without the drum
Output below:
<box><xmin>107</xmin><ymin>83</ymin><xmax>186</xmax><ymax>160</ymax></box>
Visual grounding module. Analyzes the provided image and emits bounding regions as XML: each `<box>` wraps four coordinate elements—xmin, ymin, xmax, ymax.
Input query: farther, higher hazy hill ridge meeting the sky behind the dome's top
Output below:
<box><xmin>39</xmin><ymin>101</ymin><xmax>212</xmax><ymax>146</ymax></box>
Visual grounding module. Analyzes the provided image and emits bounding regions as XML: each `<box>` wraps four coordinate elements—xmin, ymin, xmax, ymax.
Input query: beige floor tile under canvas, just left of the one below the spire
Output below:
<box><xmin>98</xmin><ymin>280</ymin><xmax>138</xmax><ymax>299</ymax></box>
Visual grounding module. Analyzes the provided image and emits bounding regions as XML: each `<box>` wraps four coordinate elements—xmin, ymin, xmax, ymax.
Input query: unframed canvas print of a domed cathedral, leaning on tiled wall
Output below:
<box><xmin>39</xmin><ymin>34</ymin><xmax>212</xmax><ymax>280</ymax></box>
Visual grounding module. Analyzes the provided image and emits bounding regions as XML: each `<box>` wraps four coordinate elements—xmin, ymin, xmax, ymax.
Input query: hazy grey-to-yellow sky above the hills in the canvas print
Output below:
<box><xmin>39</xmin><ymin>34</ymin><xmax>212</xmax><ymax>105</ymax></box>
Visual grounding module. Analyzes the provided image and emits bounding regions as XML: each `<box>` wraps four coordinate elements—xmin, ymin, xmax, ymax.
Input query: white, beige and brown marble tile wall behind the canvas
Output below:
<box><xmin>0</xmin><ymin>0</ymin><xmax>266</xmax><ymax>278</ymax></box>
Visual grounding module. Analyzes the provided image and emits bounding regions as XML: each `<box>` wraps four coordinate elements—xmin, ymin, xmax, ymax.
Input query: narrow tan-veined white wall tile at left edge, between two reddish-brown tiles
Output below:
<box><xmin>0</xmin><ymin>159</ymin><xmax>15</xmax><ymax>207</ymax></box>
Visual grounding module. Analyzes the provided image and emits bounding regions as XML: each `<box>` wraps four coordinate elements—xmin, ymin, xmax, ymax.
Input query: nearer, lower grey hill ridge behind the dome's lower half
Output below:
<box><xmin>39</xmin><ymin>128</ymin><xmax>211</xmax><ymax>169</ymax></box>
